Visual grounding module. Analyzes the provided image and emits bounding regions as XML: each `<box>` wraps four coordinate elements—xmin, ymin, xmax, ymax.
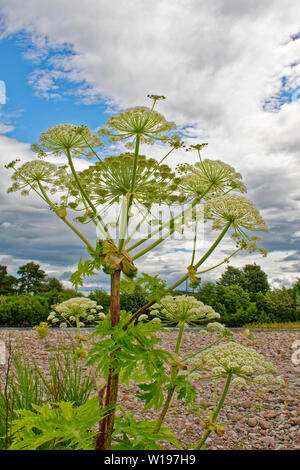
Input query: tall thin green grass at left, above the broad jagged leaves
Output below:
<box><xmin>0</xmin><ymin>343</ymin><xmax>95</xmax><ymax>451</ymax></box>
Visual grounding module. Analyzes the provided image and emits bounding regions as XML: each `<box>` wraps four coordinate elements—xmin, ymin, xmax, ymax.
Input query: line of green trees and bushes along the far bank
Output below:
<box><xmin>0</xmin><ymin>262</ymin><xmax>300</xmax><ymax>326</ymax></box>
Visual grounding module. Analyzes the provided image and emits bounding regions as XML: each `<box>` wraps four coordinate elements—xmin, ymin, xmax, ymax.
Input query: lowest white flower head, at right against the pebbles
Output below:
<box><xmin>188</xmin><ymin>341</ymin><xmax>283</xmax><ymax>386</ymax></box>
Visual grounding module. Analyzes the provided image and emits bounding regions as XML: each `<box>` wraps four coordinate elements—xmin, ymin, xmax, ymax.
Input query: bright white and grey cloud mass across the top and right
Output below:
<box><xmin>0</xmin><ymin>0</ymin><xmax>300</xmax><ymax>288</ymax></box>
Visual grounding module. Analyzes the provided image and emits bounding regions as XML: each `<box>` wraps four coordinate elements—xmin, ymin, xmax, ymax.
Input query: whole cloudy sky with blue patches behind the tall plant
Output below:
<box><xmin>0</xmin><ymin>0</ymin><xmax>300</xmax><ymax>291</ymax></box>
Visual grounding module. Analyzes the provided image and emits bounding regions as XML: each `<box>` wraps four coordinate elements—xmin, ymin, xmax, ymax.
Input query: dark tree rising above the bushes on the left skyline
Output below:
<box><xmin>17</xmin><ymin>261</ymin><xmax>46</xmax><ymax>294</ymax></box>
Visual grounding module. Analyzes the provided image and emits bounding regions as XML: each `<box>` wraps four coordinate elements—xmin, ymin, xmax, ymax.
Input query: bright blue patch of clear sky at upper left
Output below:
<box><xmin>0</xmin><ymin>37</ymin><xmax>108</xmax><ymax>143</ymax></box>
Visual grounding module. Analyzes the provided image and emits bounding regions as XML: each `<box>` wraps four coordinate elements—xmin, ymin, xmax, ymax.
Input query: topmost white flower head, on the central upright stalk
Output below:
<box><xmin>99</xmin><ymin>106</ymin><xmax>176</xmax><ymax>144</ymax></box>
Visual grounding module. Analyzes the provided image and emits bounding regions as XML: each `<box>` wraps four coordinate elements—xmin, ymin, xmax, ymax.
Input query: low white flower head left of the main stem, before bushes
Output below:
<box><xmin>48</xmin><ymin>297</ymin><xmax>105</xmax><ymax>328</ymax></box>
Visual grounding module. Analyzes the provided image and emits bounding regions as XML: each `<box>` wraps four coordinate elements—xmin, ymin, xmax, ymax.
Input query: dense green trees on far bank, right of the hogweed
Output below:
<box><xmin>196</xmin><ymin>264</ymin><xmax>300</xmax><ymax>326</ymax></box>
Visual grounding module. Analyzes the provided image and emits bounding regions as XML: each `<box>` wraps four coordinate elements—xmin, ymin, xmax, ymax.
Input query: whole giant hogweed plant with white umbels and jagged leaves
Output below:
<box><xmin>7</xmin><ymin>95</ymin><xmax>282</xmax><ymax>450</ymax></box>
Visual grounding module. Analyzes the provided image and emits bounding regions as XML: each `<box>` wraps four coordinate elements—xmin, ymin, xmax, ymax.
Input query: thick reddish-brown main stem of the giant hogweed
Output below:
<box><xmin>96</xmin><ymin>270</ymin><xmax>121</xmax><ymax>450</ymax></box>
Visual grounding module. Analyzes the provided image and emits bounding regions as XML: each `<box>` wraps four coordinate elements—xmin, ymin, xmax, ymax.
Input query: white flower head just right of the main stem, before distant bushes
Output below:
<box><xmin>150</xmin><ymin>295</ymin><xmax>220</xmax><ymax>326</ymax></box>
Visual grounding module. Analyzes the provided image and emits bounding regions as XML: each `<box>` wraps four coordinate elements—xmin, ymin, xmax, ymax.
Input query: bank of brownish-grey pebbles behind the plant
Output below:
<box><xmin>0</xmin><ymin>329</ymin><xmax>300</xmax><ymax>450</ymax></box>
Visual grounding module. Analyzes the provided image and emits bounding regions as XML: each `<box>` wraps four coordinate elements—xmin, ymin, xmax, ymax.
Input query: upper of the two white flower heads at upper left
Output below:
<box><xmin>31</xmin><ymin>124</ymin><xmax>103</xmax><ymax>157</ymax></box>
